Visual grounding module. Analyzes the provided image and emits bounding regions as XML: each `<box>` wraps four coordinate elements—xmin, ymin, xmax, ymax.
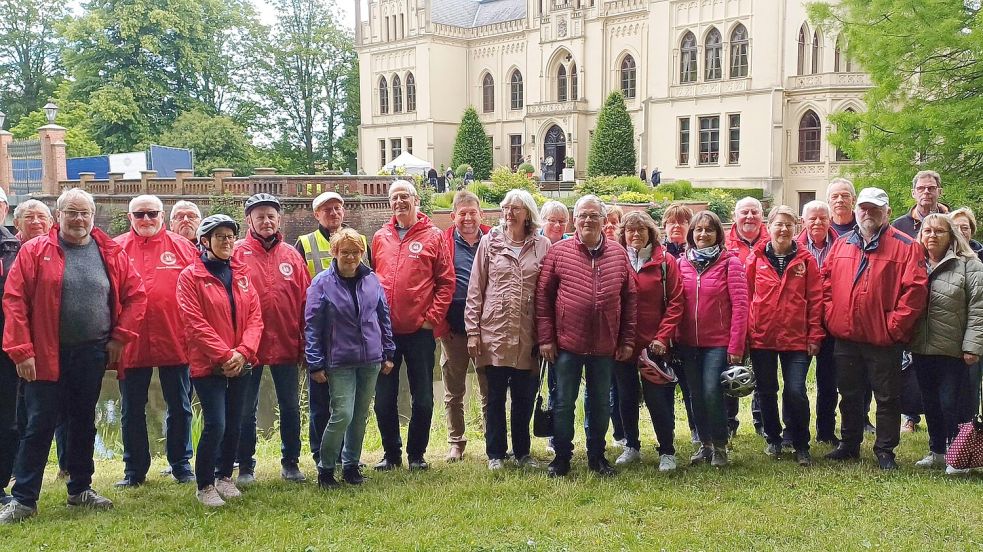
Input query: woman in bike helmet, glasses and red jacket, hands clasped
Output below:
<box><xmin>177</xmin><ymin>215</ymin><xmax>263</xmax><ymax>507</ymax></box>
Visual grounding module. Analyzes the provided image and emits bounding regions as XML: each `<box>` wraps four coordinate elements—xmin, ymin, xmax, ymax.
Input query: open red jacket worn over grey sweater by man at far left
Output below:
<box><xmin>3</xmin><ymin>226</ymin><xmax>147</xmax><ymax>381</ymax></box>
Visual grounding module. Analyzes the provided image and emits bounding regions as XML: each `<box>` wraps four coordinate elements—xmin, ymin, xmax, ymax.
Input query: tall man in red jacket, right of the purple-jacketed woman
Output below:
<box><xmin>372</xmin><ymin>180</ymin><xmax>454</xmax><ymax>470</ymax></box>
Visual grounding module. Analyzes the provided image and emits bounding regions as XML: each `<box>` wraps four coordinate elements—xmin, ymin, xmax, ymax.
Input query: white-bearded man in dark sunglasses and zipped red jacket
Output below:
<box><xmin>116</xmin><ymin>195</ymin><xmax>198</xmax><ymax>487</ymax></box>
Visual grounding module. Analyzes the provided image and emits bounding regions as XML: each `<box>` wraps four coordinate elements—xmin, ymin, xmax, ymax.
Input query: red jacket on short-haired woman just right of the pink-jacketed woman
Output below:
<box><xmin>745</xmin><ymin>242</ymin><xmax>826</xmax><ymax>352</ymax></box>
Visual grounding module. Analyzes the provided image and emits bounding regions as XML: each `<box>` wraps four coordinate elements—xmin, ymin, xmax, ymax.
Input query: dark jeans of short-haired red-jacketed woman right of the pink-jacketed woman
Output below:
<box><xmin>751</xmin><ymin>349</ymin><xmax>810</xmax><ymax>451</ymax></box>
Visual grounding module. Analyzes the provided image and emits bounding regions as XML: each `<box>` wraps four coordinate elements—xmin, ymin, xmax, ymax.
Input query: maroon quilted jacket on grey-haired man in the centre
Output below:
<box><xmin>536</xmin><ymin>235</ymin><xmax>637</xmax><ymax>356</ymax></box>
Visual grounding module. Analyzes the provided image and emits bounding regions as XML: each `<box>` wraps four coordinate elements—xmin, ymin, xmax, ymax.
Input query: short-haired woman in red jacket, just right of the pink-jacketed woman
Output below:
<box><xmin>746</xmin><ymin>205</ymin><xmax>825</xmax><ymax>466</ymax></box>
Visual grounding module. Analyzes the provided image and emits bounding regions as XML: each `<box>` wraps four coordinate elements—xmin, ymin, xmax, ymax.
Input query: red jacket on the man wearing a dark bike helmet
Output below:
<box><xmin>232</xmin><ymin>232</ymin><xmax>311</xmax><ymax>365</ymax></box>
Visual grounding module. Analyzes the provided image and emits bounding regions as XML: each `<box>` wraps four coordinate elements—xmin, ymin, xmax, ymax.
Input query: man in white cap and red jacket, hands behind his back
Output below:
<box><xmin>822</xmin><ymin>188</ymin><xmax>928</xmax><ymax>470</ymax></box>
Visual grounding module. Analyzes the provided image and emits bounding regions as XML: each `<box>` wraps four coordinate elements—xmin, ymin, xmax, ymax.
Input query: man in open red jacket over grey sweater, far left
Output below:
<box><xmin>0</xmin><ymin>188</ymin><xmax>147</xmax><ymax>524</ymax></box>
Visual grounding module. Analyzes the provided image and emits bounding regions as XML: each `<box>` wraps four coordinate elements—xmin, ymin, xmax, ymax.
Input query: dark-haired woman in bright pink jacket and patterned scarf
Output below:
<box><xmin>677</xmin><ymin>211</ymin><xmax>747</xmax><ymax>467</ymax></box>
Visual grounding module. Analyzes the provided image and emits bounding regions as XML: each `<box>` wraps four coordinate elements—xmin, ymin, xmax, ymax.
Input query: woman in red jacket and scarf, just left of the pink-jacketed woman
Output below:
<box><xmin>614</xmin><ymin>211</ymin><xmax>683</xmax><ymax>471</ymax></box>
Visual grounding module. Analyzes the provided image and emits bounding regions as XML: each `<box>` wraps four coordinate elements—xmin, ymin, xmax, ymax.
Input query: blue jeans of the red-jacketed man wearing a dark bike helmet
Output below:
<box><xmin>236</xmin><ymin>364</ymin><xmax>300</xmax><ymax>473</ymax></box>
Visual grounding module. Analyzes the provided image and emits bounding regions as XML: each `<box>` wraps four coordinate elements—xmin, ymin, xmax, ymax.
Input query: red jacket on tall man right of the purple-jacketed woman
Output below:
<box><xmin>372</xmin><ymin>213</ymin><xmax>455</xmax><ymax>337</ymax></box>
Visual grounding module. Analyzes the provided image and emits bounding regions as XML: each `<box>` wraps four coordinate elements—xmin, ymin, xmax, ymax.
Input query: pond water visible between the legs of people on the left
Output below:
<box><xmin>90</xmin><ymin>354</ymin><xmax>477</xmax><ymax>459</ymax></box>
